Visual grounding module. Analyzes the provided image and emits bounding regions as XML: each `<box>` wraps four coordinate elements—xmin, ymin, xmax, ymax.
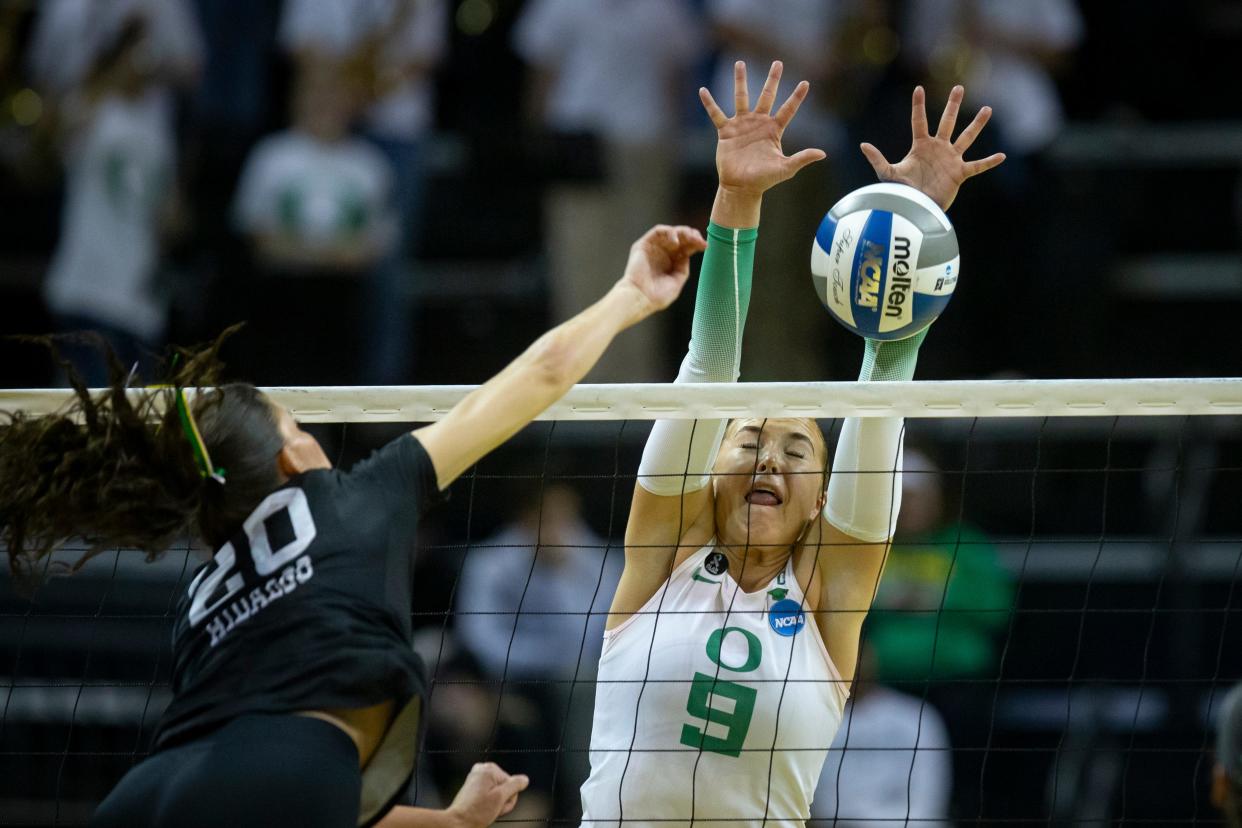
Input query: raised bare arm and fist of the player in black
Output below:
<box><xmin>414</xmin><ymin>225</ymin><xmax>707</xmax><ymax>489</ymax></box>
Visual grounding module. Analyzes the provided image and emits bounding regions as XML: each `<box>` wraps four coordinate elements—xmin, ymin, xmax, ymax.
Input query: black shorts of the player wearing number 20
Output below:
<box><xmin>91</xmin><ymin>715</ymin><xmax>363</xmax><ymax>828</ymax></box>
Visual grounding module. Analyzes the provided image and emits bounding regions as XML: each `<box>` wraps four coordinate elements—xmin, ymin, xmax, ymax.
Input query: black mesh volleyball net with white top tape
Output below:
<box><xmin>0</xmin><ymin>380</ymin><xmax>1242</xmax><ymax>826</ymax></box>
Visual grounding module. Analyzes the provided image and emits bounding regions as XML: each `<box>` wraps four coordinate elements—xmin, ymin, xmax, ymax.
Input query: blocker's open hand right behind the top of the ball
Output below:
<box><xmin>861</xmin><ymin>86</ymin><xmax>1005</xmax><ymax>210</ymax></box>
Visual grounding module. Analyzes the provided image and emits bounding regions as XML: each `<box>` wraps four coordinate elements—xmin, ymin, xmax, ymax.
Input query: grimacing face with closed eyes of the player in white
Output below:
<box><xmin>714</xmin><ymin>420</ymin><xmax>827</xmax><ymax>546</ymax></box>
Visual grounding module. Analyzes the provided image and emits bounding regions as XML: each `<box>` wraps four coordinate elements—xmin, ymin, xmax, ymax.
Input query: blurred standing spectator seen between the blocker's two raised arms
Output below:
<box><xmin>705</xmin><ymin>0</ymin><xmax>888</xmax><ymax>380</ymax></box>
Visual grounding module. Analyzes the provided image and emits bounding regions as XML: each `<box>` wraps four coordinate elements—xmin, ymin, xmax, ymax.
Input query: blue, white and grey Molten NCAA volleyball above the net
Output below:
<box><xmin>811</xmin><ymin>184</ymin><xmax>960</xmax><ymax>341</ymax></box>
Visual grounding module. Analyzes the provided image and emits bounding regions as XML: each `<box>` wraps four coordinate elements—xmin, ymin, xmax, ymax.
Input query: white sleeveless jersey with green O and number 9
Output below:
<box><xmin>581</xmin><ymin>544</ymin><xmax>847</xmax><ymax>828</ymax></box>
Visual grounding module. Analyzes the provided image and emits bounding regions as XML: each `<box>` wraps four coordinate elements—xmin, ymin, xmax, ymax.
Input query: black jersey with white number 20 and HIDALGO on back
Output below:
<box><xmin>155</xmin><ymin>434</ymin><xmax>441</xmax><ymax>824</ymax></box>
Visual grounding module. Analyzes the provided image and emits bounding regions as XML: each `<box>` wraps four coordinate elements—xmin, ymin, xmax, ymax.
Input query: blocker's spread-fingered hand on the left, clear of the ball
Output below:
<box><xmin>699</xmin><ymin>61</ymin><xmax>825</xmax><ymax>196</ymax></box>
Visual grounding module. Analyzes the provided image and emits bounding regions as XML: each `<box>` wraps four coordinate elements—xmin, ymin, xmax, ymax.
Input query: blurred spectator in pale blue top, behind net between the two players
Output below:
<box><xmin>456</xmin><ymin>483</ymin><xmax>621</xmax><ymax>817</ymax></box>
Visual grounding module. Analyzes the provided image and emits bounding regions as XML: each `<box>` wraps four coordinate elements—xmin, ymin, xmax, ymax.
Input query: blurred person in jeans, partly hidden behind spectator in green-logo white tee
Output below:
<box><xmin>281</xmin><ymin>0</ymin><xmax>448</xmax><ymax>385</ymax></box>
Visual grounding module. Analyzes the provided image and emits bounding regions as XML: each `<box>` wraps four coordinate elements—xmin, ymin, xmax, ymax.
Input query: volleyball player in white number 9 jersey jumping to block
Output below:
<box><xmin>582</xmin><ymin>63</ymin><xmax>1004</xmax><ymax>828</ymax></box>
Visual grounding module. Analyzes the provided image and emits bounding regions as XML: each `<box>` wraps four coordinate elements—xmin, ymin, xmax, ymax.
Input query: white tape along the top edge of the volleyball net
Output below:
<box><xmin>0</xmin><ymin>377</ymin><xmax>1242</xmax><ymax>422</ymax></box>
